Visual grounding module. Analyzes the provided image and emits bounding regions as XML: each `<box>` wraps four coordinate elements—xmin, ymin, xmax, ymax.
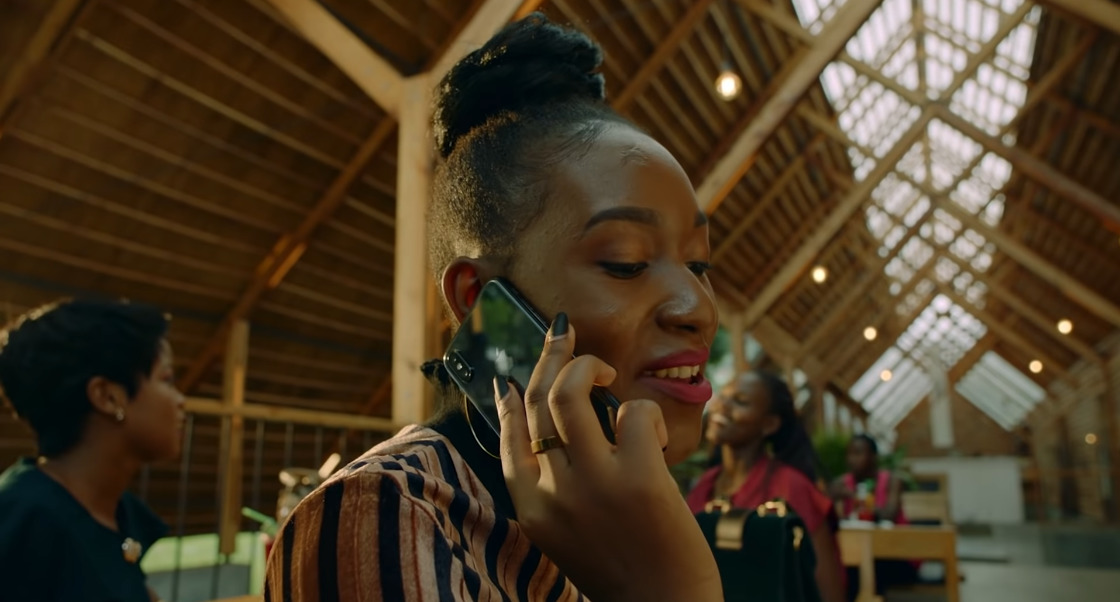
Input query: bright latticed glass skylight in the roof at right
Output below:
<box><xmin>793</xmin><ymin>0</ymin><xmax>1039</xmax><ymax>434</ymax></box>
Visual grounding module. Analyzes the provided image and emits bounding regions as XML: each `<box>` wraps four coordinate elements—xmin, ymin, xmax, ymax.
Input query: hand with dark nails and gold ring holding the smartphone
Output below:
<box><xmin>496</xmin><ymin>317</ymin><xmax>724</xmax><ymax>602</ymax></box>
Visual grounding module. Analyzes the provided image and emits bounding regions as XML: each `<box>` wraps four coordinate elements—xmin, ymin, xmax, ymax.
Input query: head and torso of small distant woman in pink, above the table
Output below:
<box><xmin>832</xmin><ymin>434</ymin><xmax>906</xmax><ymax>525</ymax></box>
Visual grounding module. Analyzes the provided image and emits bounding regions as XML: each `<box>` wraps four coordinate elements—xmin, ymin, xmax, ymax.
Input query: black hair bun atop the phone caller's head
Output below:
<box><xmin>432</xmin><ymin>12</ymin><xmax>606</xmax><ymax>158</ymax></box>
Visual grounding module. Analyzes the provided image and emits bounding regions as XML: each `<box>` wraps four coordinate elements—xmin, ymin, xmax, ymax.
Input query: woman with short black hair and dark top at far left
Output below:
<box><xmin>0</xmin><ymin>301</ymin><xmax>184</xmax><ymax>602</ymax></box>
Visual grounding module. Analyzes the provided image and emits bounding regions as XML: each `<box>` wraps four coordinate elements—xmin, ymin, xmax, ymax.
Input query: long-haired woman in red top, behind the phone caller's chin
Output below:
<box><xmin>688</xmin><ymin>370</ymin><xmax>843</xmax><ymax>602</ymax></box>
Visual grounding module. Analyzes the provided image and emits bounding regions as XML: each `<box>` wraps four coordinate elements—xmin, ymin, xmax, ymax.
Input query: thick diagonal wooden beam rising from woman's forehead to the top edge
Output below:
<box><xmin>697</xmin><ymin>0</ymin><xmax>881</xmax><ymax>215</ymax></box>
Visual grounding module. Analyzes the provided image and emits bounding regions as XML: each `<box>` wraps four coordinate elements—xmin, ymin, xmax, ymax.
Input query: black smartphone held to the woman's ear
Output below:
<box><xmin>444</xmin><ymin>279</ymin><xmax>619</xmax><ymax>443</ymax></box>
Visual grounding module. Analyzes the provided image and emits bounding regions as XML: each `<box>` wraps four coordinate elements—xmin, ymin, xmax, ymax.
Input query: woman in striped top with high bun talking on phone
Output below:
<box><xmin>267</xmin><ymin>15</ymin><xmax>722</xmax><ymax>602</ymax></box>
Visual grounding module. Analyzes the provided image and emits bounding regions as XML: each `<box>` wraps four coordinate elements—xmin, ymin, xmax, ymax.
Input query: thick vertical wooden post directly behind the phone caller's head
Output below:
<box><xmin>393</xmin><ymin>74</ymin><xmax>435</xmax><ymax>424</ymax></box>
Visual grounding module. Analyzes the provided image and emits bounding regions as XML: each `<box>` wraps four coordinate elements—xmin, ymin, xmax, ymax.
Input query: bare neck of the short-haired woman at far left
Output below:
<box><xmin>39</xmin><ymin>438</ymin><xmax>140</xmax><ymax>530</ymax></box>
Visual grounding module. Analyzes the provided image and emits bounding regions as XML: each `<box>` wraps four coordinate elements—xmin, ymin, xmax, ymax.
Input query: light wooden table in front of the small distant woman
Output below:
<box><xmin>837</xmin><ymin>526</ymin><xmax>961</xmax><ymax>602</ymax></box>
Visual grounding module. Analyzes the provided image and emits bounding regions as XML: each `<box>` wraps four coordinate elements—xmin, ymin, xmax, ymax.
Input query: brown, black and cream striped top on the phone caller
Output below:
<box><xmin>264</xmin><ymin>417</ymin><xmax>584</xmax><ymax>602</ymax></box>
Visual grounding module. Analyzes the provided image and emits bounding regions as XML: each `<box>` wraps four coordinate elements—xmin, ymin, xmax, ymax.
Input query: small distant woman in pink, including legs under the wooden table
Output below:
<box><xmin>832</xmin><ymin>434</ymin><xmax>921</xmax><ymax>600</ymax></box>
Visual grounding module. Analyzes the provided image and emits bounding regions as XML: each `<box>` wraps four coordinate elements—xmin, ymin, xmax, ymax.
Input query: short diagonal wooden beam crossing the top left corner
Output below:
<box><xmin>0</xmin><ymin>0</ymin><xmax>86</xmax><ymax>128</ymax></box>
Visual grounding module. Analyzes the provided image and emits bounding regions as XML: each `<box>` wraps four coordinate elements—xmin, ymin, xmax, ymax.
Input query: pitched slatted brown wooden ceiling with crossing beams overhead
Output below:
<box><xmin>0</xmin><ymin>0</ymin><xmax>1120</xmax><ymax>431</ymax></box>
